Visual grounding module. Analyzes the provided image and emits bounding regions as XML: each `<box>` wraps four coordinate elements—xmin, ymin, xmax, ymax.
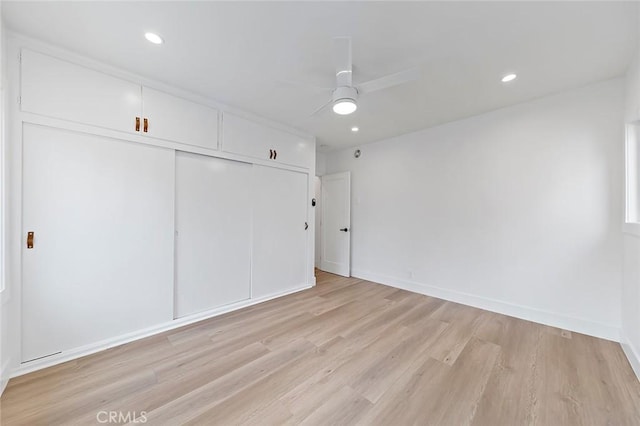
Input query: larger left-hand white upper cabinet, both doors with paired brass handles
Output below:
<box><xmin>20</xmin><ymin>49</ymin><xmax>218</xmax><ymax>149</ymax></box>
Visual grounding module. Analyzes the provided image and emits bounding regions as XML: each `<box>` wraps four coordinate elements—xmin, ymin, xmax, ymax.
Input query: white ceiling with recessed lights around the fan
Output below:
<box><xmin>2</xmin><ymin>1</ymin><xmax>638</xmax><ymax>149</ymax></box>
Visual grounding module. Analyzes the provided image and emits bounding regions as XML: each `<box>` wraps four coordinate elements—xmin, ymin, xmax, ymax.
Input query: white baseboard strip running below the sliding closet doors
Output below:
<box><xmin>9</xmin><ymin>284</ymin><xmax>313</xmax><ymax>378</ymax></box>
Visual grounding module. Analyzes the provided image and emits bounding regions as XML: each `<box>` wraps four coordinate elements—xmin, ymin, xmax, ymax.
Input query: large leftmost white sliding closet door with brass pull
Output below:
<box><xmin>22</xmin><ymin>124</ymin><xmax>175</xmax><ymax>362</ymax></box>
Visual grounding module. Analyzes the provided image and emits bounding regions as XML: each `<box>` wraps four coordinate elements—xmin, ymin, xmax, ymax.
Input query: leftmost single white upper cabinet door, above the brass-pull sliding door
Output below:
<box><xmin>20</xmin><ymin>49</ymin><xmax>142</xmax><ymax>133</ymax></box>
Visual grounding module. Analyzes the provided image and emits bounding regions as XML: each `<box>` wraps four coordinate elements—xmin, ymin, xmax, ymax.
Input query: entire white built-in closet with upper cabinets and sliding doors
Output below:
<box><xmin>15</xmin><ymin>49</ymin><xmax>315</xmax><ymax>363</ymax></box>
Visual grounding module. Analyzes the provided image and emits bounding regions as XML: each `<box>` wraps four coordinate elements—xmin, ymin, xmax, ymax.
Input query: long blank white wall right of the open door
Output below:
<box><xmin>327</xmin><ymin>79</ymin><xmax>624</xmax><ymax>340</ymax></box>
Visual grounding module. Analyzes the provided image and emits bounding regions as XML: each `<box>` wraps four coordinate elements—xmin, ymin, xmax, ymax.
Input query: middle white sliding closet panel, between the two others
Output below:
<box><xmin>176</xmin><ymin>152</ymin><xmax>252</xmax><ymax>317</ymax></box>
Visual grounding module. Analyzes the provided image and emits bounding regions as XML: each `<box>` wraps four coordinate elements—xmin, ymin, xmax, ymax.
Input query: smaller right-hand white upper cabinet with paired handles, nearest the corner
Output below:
<box><xmin>222</xmin><ymin>113</ymin><xmax>315</xmax><ymax>168</ymax></box>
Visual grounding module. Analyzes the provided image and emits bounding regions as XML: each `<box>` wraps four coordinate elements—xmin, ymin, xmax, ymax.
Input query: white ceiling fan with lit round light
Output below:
<box><xmin>302</xmin><ymin>37</ymin><xmax>420</xmax><ymax>116</ymax></box>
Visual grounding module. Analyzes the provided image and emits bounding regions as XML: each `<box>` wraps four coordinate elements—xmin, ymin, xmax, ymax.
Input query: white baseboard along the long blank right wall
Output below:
<box><xmin>351</xmin><ymin>269</ymin><xmax>620</xmax><ymax>342</ymax></box>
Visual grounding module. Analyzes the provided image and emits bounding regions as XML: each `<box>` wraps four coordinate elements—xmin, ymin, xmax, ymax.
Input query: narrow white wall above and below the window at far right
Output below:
<box><xmin>621</xmin><ymin>21</ymin><xmax>640</xmax><ymax>378</ymax></box>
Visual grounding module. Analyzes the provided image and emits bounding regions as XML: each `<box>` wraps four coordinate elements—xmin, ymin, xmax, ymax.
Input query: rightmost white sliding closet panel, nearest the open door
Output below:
<box><xmin>251</xmin><ymin>165</ymin><xmax>309</xmax><ymax>297</ymax></box>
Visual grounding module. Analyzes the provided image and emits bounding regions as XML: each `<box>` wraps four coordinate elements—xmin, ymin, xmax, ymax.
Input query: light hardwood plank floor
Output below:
<box><xmin>0</xmin><ymin>272</ymin><xmax>640</xmax><ymax>426</ymax></box>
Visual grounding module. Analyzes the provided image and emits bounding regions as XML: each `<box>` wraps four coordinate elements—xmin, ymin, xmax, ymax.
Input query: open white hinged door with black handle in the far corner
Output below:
<box><xmin>320</xmin><ymin>172</ymin><xmax>351</xmax><ymax>277</ymax></box>
